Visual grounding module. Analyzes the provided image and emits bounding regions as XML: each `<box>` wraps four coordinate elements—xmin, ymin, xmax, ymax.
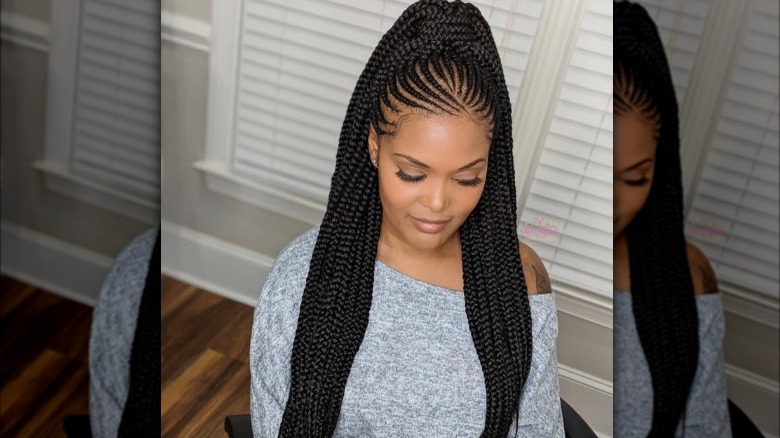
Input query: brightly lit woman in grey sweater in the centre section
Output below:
<box><xmin>250</xmin><ymin>0</ymin><xmax>563</xmax><ymax>437</ymax></box>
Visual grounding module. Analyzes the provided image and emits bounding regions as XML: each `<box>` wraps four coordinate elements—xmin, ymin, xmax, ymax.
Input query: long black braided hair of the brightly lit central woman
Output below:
<box><xmin>279</xmin><ymin>0</ymin><xmax>532</xmax><ymax>437</ymax></box>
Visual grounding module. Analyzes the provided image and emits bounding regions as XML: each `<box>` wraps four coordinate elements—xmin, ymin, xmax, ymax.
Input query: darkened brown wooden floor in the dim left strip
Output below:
<box><xmin>0</xmin><ymin>275</ymin><xmax>92</xmax><ymax>438</ymax></box>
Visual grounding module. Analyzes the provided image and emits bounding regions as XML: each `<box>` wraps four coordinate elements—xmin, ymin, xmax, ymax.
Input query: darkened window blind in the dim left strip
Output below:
<box><xmin>70</xmin><ymin>0</ymin><xmax>160</xmax><ymax>204</ymax></box>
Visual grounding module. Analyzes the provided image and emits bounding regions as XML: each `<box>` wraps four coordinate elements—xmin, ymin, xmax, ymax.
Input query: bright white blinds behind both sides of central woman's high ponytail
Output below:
<box><xmin>230</xmin><ymin>0</ymin><xmax>544</xmax><ymax>205</ymax></box>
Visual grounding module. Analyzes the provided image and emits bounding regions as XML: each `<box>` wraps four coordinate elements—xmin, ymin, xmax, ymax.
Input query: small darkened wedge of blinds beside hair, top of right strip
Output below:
<box><xmin>640</xmin><ymin>0</ymin><xmax>712</xmax><ymax>109</ymax></box>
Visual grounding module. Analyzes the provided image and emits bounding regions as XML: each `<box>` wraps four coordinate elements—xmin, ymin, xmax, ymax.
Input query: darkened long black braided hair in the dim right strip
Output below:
<box><xmin>613</xmin><ymin>2</ymin><xmax>699</xmax><ymax>436</ymax></box>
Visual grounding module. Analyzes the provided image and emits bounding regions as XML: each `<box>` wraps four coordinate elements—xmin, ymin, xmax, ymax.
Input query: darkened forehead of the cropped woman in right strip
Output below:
<box><xmin>613</xmin><ymin>112</ymin><xmax>658</xmax><ymax>171</ymax></box>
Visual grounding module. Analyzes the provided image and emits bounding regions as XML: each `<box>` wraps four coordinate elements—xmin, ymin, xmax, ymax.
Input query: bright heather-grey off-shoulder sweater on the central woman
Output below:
<box><xmin>250</xmin><ymin>227</ymin><xmax>564</xmax><ymax>438</ymax></box>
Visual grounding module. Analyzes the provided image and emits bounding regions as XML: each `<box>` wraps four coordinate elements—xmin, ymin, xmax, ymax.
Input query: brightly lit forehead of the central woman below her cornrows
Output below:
<box><xmin>386</xmin><ymin>114</ymin><xmax>490</xmax><ymax>159</ymax></box>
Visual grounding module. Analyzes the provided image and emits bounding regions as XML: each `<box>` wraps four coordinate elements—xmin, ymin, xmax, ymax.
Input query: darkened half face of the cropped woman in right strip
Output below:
<box><xmin>613</xmin><ymin>112</ymin><xmax>658</xmax><ymax>238</ymax></box>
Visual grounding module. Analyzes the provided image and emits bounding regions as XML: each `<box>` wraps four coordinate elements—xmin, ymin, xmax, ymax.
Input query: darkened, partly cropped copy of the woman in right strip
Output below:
<box><xmin>613</xmin><ymin>2</ymin><xmax>731</xmax><ymax>437</ymax></box>
